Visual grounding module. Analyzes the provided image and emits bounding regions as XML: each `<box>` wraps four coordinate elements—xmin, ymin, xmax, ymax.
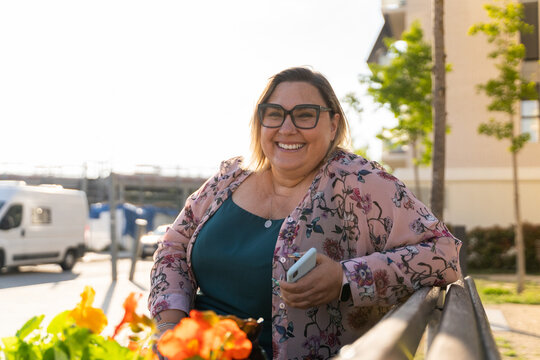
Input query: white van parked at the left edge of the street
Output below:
<box><xmin>0</xmin><ymin>181</ymin><xmax>88</xmax><ymax>270</ymax></box>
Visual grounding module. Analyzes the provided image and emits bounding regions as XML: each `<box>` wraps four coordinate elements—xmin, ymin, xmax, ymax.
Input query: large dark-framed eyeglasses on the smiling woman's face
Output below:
<box><xmin>258</xmin><ymin>104</ymin><xmax>332</xmax><ymax>129</ymax></box>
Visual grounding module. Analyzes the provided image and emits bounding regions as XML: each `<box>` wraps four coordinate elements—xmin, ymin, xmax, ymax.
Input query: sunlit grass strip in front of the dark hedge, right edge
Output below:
<box><xmin>472</xmin><ymin>275</ymin><xmax>540</xmax><ymax>305</ymax></box>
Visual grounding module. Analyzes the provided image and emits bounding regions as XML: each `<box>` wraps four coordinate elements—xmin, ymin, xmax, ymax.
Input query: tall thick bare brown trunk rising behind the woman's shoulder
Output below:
<box><xmin>431</xmin><ymin>0</ymin><xmax>446</xmax><ymax>220</ymax></box>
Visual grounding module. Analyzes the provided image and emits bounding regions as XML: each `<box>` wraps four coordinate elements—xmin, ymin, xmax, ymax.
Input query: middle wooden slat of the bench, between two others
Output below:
<box><xmin>426</xmin><ymin>280</ymin><xmax>484</xmax><ymax>360</ymax></box>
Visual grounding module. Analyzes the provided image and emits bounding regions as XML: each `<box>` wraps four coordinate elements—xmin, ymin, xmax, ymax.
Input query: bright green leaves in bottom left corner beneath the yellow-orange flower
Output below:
<box><xmin>0</xmin><ymin>311</ymin><xmax>143</xmax><ymax>360</ymax></box>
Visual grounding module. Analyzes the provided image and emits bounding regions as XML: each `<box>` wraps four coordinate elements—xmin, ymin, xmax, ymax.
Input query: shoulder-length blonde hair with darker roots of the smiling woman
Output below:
<box><xmin>249</xmin><ymin>67</ymin><xmax>351</xmax><ymax>171</ymax></box>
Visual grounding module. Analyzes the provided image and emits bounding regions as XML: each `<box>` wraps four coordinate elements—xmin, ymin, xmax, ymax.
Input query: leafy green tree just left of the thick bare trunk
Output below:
<box><xmin>348</xmin><ymin>22</ymin><xmax>433</xmax><ymax>201</ymax></box>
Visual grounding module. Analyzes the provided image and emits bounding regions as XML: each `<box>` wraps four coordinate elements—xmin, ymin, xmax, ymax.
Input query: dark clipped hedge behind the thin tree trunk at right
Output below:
<box><xmin>467</xmin><ymin>224</ymin><xmax>540</xmax><ymax>272</ymax></box>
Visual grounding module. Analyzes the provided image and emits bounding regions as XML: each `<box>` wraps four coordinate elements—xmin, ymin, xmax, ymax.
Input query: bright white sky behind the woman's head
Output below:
<box><xmin>0</xmin><ymin>0</ymin><xmax>388</xmax><ymax>176</ymax></box>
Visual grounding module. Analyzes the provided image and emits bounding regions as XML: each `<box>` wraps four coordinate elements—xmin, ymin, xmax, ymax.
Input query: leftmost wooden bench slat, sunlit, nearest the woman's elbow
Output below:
<box><xmin>337</xmin><ymin>287</ymin><xmax>440</xmax><ymax>360</ymax></box>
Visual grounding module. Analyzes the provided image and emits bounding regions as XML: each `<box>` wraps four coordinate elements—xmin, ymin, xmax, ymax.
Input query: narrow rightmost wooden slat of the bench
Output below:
<box><xmin>465</xmin><ymin>276</ymin><xmax>501</xmax><ymax>360</ymax></box>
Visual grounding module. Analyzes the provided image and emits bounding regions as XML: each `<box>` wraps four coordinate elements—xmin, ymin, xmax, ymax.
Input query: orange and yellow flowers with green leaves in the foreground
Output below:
<box><xmin>0</xmin><ymin>286</ymin><xmax>260</xmax><ymax>360</ymax></box>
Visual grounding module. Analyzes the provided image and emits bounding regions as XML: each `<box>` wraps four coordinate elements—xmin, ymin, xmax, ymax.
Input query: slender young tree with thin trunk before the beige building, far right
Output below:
<box><xmin>469</xmin><ymin>1</ymin><xmax>538</xmax><ymax>293</ymax></box>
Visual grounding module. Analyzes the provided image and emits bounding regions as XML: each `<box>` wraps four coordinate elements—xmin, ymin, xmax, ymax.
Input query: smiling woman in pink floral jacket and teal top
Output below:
<box><xmin>149</xmin><ymin>68</ymin><xmax>461</xmax><ymax>359</ymax></box>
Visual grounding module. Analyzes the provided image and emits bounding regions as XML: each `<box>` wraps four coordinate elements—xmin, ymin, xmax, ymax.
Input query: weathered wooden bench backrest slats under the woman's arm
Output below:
<box><xmin>337</xmin><ymin>276</ymin><xmax>500</xmax><ymax>360</ymax></box>
